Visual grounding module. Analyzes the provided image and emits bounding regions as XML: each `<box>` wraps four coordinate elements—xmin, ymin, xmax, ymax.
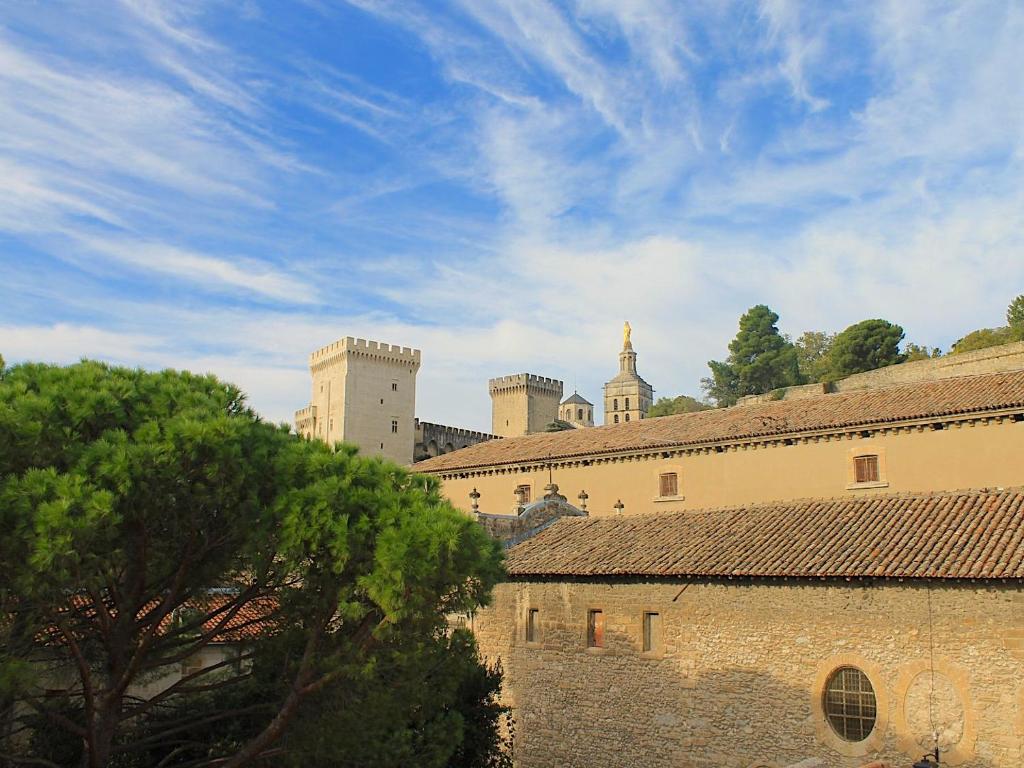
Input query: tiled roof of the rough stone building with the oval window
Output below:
<box><xmin>506</xmin><ymin>487</ymin><xmax>1024</xmax><ymax>579</ymax></box>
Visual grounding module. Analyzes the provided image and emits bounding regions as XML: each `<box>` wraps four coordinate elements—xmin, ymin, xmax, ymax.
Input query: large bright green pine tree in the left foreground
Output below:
<box><xmin>0</xmin><ymin>361</ymin><xmax>502</xmax><ymax>768</ymax></box>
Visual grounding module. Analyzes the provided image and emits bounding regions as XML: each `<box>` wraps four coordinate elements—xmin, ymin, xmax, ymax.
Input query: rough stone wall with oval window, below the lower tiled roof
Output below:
<box><xmin>472</xmin><ymin>581</ymin><xmax>1024</xmax><ymax>768</ymax></box>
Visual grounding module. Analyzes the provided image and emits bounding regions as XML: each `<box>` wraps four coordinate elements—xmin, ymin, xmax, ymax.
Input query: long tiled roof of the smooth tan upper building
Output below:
<box><xmin>413</xmin><ymin>371</ymin><xmax>1024</xmax><ymax>472</ymax></box>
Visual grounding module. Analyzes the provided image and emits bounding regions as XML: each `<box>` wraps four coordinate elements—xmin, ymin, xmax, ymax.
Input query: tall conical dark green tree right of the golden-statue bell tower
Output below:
<box><xmin>701</xmin><ymin>304</ymin><xmax>802</xmax><ymax>406</ymax></box>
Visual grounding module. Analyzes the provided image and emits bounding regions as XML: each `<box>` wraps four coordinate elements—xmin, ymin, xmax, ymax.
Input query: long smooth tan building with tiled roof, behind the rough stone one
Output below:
<box><xmin>416</xmin><ymin>371</ymin><xmax>1024</xmax><ymax>516</ymax></box>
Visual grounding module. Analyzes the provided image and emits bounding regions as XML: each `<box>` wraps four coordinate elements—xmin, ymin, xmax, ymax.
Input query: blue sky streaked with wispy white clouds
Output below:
<box><xmin>0</xmin><ymin>0</ymin><xmax>1024</xmax><ymax>428</ymax></box>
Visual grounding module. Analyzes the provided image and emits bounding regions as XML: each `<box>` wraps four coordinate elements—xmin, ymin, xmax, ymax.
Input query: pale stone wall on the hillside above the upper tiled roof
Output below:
<box><xmin>739</xmin><ymin>341</ymin><xmax>1024</xmax><ymax>406</ymax></box>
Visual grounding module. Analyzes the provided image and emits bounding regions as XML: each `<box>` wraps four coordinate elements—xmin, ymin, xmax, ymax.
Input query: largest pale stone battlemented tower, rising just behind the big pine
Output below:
<box><xmin>295</xmin><ymin>336</ymin><xmax>420</xmax><ymax>464</ymax></box>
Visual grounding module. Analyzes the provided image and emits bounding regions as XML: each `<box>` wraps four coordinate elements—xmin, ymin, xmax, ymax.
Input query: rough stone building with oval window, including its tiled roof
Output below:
<box><xmin>471</xmin><ymin>488</ymin><xmax>1024</xmax><ymax>768</ymax></box>
